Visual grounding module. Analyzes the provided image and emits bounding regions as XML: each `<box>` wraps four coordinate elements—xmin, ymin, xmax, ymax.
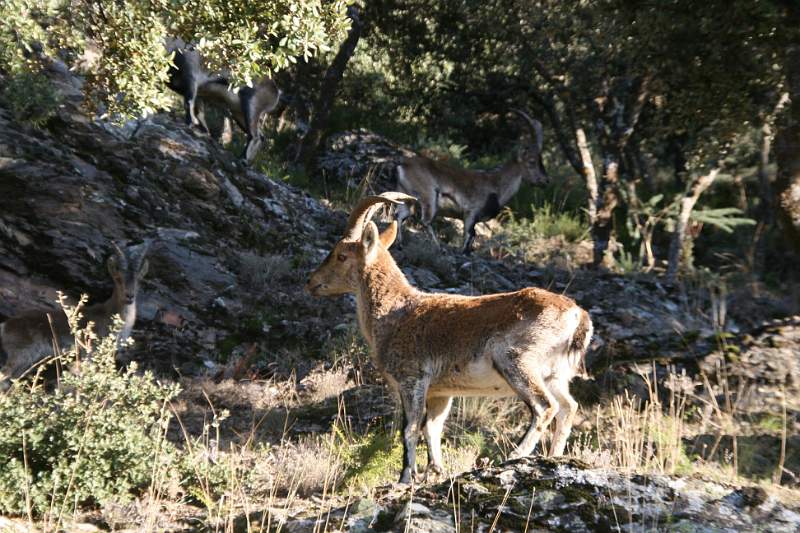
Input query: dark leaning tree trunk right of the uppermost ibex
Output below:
<box><xmin>297</xmin><ymin>5</ymin><xmax>364</xmax><ymax>173</ymax></box>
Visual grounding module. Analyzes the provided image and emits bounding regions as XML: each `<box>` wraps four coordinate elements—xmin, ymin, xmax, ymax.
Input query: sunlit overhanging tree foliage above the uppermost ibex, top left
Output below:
<box><xmin>0</xmin><ymin>0</ymin><xmax>348</xmax><ymax>116</ymax></box>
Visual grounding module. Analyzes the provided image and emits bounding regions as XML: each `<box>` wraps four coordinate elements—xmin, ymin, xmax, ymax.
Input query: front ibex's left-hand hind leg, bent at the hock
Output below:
<box><xmin>494</xmin><ymin>354</ymin><xmax>560</xmax><ymax>459</ymax></box>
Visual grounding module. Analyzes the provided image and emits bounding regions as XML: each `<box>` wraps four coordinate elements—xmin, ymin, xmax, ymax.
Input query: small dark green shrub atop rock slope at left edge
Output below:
<box><xmin>2</xmin><ymin>71</ymin><xmax>61</xmax><ymax>127</ymax></box>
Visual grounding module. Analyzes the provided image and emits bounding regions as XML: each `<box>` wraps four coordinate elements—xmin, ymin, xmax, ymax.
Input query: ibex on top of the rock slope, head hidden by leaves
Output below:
<box><xmin>168</xmin><ymin>47</ymin><xmax>281</xmax><ymax>163</ymax></box>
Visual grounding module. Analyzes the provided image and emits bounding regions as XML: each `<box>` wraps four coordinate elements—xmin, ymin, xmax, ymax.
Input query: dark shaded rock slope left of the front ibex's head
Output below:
<box><xmin>0</xmin><ymin>98</ymin><xmax>346</xmax><ymax>373</ymax></box>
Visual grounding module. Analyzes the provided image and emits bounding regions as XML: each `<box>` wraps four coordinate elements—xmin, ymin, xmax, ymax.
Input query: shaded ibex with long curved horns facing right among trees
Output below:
<box><xmin>396</xmin><ymin>109</ymin><xmax>550</xmax><ymax>254</ymax></box>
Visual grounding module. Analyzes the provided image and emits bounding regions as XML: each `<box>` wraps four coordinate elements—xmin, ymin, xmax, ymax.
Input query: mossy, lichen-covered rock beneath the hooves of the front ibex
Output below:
<box><xmin>284</xmin><ymin>458</ymin><xmax>800</xmax><ymax>532</ymax></box>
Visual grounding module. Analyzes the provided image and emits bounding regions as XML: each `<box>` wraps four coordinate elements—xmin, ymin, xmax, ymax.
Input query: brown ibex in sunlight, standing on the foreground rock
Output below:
<box><xmin>306</xmin><ymin>192</ymin><xmax>592</xmax><ymax>483</ymax></box>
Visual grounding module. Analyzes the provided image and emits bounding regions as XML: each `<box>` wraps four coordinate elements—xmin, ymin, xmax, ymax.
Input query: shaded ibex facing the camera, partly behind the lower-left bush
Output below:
<box><xmin>0</xmin><ymin>242</ymin><xmax>149</xmax><ymax>389</ymax></box>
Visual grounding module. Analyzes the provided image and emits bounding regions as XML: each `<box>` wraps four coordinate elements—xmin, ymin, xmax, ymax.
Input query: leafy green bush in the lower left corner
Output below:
<box><xmin>0</xmin><ymin>302</ymin><xmax>178</xmax><ymax>515</ymax></box>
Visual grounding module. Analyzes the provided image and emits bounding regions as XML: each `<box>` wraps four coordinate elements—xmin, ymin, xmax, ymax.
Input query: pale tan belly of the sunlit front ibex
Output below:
<box><xmin>428</xmin><ymin>357</ymin><xmax>514</xmax><ymax>396</ymax></box>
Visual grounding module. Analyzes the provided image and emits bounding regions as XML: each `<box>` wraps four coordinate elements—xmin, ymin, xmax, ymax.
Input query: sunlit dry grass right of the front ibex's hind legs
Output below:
<box><xmin>571</xmin><ymin>364</ymin><xmax>787</xmax><ymax>490</ymax></box>
